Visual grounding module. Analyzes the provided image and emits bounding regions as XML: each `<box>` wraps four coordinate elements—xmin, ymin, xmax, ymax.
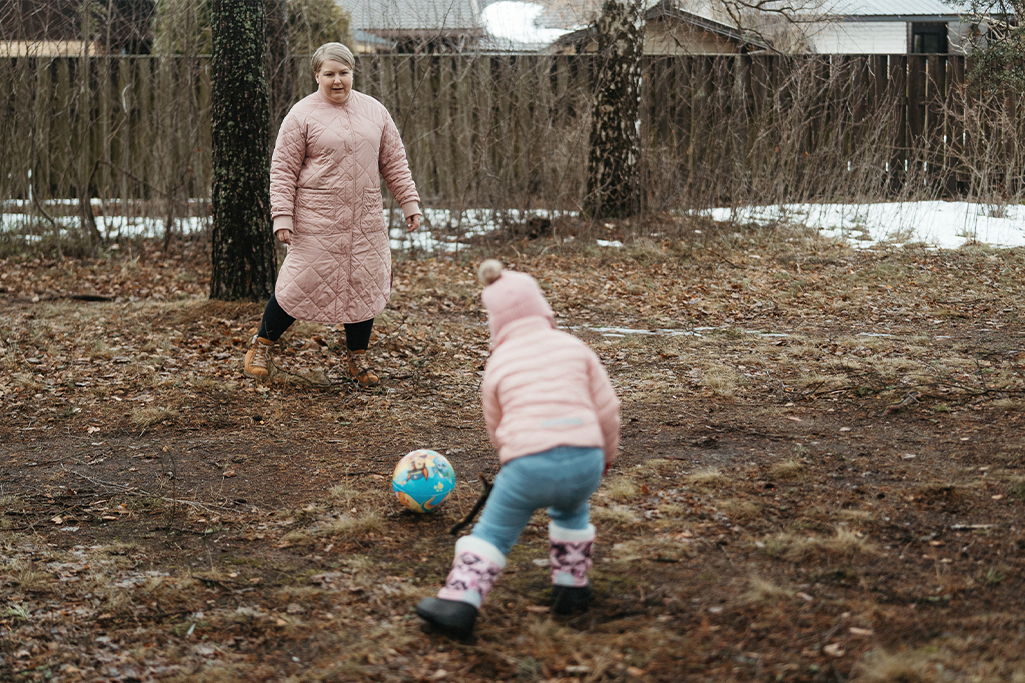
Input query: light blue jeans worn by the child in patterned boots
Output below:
<box><xmin>470</xmin><ymin>446</ymin><xmax>605</xmax><ymax>555</ymax></box>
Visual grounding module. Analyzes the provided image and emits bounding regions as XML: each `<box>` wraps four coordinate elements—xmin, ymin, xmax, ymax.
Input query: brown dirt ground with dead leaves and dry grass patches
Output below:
<box><xmin>0</xmin><ymin>219</ymin><xmax>1025</xmax><ymax>683</ymax></box>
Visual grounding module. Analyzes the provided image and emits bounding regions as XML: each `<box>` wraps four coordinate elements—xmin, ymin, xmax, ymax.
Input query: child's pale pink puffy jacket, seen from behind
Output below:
<box><xmin>481</xmin><ymin>316</ymin><xmax>619</xmax><ymax>465</ymax></box>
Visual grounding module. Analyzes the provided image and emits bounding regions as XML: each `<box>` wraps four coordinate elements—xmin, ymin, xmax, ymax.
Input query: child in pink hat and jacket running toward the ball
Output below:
<box><xmin>416</xmin><ymin>258</ymin><xmax>619</xmax><ymax>638</ymax></box>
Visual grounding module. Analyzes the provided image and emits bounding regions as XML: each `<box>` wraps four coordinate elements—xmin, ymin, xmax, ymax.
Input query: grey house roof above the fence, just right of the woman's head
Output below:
<box><xmin>336</xmin><ymin>0</ymin><xmax>481</xmax><ymax>36</ymax></box>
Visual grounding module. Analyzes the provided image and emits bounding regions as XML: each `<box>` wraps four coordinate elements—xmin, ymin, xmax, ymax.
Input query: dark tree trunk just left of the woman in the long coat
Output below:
<box><xmin>210</xmin><ymin>0</ymin><xmax>277</xmax><ymax>300</ymax></box>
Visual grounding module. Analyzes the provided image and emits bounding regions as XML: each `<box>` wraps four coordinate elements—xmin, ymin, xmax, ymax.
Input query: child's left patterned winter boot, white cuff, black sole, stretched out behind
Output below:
<box><xmin>416</xmin><ymin>536</ymin><xmax>505</xmax><ymax>640</ymax></box>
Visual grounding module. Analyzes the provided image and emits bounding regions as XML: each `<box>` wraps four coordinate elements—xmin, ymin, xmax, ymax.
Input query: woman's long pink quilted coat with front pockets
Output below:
<box><xmin>271</xmin><ymin>90</ymin><xmax>420</xmax><ymax>323</ymax></box>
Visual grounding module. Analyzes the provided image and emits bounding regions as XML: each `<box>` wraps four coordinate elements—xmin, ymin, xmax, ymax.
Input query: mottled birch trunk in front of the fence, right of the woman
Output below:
<box><xmin>584</xmin><ymin>0</ymin><xmax>644</xmax><ymax>218</ymax></box>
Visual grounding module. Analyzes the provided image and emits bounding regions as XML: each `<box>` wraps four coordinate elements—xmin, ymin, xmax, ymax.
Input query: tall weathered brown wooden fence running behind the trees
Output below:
<box><xmin>0</xmin><ymin>54</ymin><xmax>1025</xmax><ymax>220</ymax></box>
